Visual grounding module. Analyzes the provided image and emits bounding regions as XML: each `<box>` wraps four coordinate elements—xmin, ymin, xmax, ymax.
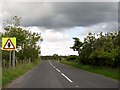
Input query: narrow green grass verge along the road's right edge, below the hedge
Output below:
<box><xmin>61</xmin><ymin>60</ymin><xmax>120</xmax><ymax>80</ymax></box>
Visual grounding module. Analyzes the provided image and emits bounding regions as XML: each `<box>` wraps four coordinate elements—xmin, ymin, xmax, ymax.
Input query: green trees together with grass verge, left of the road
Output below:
<box><xmin>2</xmin><ymin>16</ymin><xmax>43</xmax><ymax>86</ymax></box>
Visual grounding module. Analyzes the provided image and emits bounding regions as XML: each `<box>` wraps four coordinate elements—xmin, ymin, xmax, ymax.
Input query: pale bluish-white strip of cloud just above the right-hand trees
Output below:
<box><xmin>67</xmin><ymin>22</ymin><xmax>118</xmax><ymax>42</ymax></box>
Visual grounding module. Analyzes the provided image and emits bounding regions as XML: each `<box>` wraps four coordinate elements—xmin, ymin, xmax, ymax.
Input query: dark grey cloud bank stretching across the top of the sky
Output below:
<box><xmin>2</xmin><ymin>2</ymin><xmax>118</xmax><ymax>29</ymax></box>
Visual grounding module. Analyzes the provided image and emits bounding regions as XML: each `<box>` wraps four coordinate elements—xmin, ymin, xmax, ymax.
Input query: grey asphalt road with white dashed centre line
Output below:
<box><xmin>7</xmin><ymin>60</ymin><xmax>118</xmax><ymax>88</ymax></box>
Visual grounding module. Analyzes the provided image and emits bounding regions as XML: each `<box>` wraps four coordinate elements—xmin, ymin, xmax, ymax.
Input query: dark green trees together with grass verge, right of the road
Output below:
<box><xmin>61</xmin><ymin>31</ymin><xmax>120</xmax><ymax>80</ymax></box>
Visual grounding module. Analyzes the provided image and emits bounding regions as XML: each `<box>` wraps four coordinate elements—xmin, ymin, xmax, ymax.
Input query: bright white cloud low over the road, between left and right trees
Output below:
<box><xmin>27</xmin><ymin>26</ymin><xmax>78</xmax><ymax>55</ymax></box>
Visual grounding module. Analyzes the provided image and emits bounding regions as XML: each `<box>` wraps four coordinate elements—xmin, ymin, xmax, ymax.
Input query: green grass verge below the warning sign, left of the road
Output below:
<box><xmin>2</xmin><ymin>61</ymin><xmax>40</xmax><ymax>87</ymax></box>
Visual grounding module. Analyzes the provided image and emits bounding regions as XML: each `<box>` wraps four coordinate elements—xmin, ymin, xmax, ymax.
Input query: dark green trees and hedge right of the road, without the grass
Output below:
<box><xmin>69</xmin><ymin>31</ymin><xmax>120</xmax><ymax>68</ymax></box>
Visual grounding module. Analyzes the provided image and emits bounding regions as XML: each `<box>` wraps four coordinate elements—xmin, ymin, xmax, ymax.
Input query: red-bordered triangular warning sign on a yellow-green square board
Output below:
<box><xmin>2</xmin><ymin>38</ymin><xmax>16</xmax><ymax>50</ymax></box>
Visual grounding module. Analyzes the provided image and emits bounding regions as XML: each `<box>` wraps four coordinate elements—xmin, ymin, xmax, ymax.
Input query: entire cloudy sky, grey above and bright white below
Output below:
<box><xmin>0</xmin><ymin>2</ymin><xmax>118</xmax><ymax>55</ymax></box>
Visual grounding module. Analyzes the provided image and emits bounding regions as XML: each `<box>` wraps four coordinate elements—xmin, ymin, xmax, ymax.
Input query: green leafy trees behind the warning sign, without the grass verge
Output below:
<box><xmin>2</xmin><ymin>16</ymin><xmax>42</xmax><ymax>68</ymax></box>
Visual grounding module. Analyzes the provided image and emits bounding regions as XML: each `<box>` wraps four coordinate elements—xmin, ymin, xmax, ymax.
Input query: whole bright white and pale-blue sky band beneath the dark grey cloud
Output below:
<box><xmin>20</xmin><ymin>22</ymin><xmax>118</xmax><ymax>55</ymax></box>
